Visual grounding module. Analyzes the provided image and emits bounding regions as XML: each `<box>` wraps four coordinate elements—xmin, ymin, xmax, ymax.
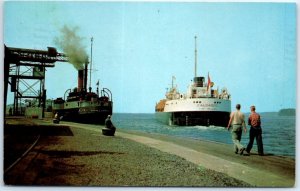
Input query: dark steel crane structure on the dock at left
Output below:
<box><xmin>4</xmin><ymin>45</ymin><xmax>68</xmax><ymax>117</ymax></box>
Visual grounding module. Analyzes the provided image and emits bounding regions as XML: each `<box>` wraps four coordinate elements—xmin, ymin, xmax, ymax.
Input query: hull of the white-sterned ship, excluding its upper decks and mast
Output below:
<box><xmin>155</xmin><ymin>98</ymin><xmax>231</xmax><ymax>127</ymax></box>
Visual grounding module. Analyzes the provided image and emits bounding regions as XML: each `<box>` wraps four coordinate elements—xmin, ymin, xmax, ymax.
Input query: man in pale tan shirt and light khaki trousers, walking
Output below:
<box><xmin>227</xmin><ymin>104</ymin><xmax>247</xmax><ymax>155</ymax></box>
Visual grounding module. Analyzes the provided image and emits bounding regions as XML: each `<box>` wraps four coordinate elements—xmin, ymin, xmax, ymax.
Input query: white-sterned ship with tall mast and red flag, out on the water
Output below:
<box><xmin>155</xmin><ymin>36</ymin><xmax>231</xmax><ymax>127</ymax></box>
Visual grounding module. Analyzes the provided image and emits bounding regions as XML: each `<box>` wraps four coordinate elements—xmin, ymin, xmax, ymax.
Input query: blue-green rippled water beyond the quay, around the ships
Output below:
<box><xmin>112</xmin><ymin>113</ymin><xmax>296</xmax><ymax>157</ymax></box>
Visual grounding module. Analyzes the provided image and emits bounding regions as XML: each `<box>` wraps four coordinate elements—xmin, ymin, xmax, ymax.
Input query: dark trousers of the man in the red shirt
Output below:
<box><xmin>246</xmin><ymin>127</ymin><xmax>264</xmax><ymax>155</ymax></box>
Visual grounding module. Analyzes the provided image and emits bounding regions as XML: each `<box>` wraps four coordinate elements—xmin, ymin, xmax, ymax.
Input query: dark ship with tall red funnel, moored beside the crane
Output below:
<box><xmin>52</xmin><ymin>39</ymin><xmax>113</xmax><ymax>124</ymax></box>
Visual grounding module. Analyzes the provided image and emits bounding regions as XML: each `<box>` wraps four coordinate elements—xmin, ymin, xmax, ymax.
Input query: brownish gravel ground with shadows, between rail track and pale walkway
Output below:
<box><xmin>4</xmin><ymin>118</ymin><xmax>251</xmax><ymax>187</ymax></box>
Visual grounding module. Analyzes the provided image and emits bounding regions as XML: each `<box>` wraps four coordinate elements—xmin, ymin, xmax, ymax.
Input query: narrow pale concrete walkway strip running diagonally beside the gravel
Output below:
<box><xmin>70</xmin><ymin>123</ymin><xmax>295</xmax><ymax>187</ymax></box>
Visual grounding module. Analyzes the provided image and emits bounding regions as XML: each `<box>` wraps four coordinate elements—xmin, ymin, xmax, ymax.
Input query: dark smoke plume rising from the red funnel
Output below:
<box><xmin>54</xmin><ymin>25</ymin><xmax>88</xmax><ymax>70</ymax></box>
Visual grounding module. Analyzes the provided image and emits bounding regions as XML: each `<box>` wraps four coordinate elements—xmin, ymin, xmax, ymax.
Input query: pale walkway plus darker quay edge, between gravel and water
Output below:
<box><xmin>63</xmin><ymin>124</ymin><xmax>295</xmax><ymax>187</ymax></box>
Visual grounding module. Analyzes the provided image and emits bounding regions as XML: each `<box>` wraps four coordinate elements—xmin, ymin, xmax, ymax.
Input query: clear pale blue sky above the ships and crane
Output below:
<box><xmin>3</xmin><ymin>1</ymin><xmax>297</xmax><ymax>113</ymax></box>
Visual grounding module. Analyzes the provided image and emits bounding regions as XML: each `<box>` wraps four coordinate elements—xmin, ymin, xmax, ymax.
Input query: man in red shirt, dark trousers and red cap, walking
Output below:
<box><xmin>246</xmin><ymin>106</ymin><xmax>264</xmax><ymax>156</ymax></box>
